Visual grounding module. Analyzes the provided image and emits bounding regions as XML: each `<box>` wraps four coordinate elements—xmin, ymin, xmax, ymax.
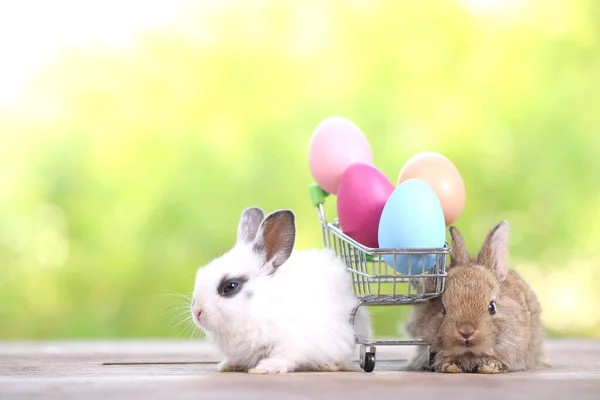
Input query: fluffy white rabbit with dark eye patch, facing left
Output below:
<box><xmin>191</xmin><ymin>207</ymin><xmax>371</xmax><ymax>374</ymax></box>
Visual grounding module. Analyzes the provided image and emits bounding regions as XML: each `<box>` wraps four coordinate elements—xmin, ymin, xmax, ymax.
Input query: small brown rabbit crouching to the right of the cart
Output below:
<box><xmin>407</xmin><ymin>221</ymin><xmax>545</xmax><ymax>374</ymax></box>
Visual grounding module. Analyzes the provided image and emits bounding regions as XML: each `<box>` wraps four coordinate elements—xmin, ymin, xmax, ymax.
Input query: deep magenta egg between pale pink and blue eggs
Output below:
<box><xmin>337</xmin><ymin>162</ymin><xmax>394</xmax><ymax>247</ymax></box>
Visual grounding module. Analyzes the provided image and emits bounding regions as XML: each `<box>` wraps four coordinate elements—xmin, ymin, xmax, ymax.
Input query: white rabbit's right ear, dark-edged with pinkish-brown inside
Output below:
<box><xmin>253</xmin><ymin>210</ymin><xmax>296</xmax><ymax>275</ymax></box>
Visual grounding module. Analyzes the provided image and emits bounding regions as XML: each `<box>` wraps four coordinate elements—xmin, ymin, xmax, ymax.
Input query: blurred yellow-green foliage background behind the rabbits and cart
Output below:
<box><xmin>0</xmin><ymin>0</ymin><xmax>600</xmax><ymax>338</ymax></box>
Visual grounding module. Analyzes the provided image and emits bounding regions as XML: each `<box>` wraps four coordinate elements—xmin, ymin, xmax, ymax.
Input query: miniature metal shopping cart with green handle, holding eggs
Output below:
<box><xmin>310</xmin><ymin>184</ymin><xmax>450</xmax><ymax>372</ymax></box>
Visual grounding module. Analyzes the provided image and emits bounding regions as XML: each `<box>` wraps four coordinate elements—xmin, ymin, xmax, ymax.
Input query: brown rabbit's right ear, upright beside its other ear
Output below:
<box><xmin>477</xmin><ymin>221</ymin><xmax>509</xmax><ymax>282</ymax></box>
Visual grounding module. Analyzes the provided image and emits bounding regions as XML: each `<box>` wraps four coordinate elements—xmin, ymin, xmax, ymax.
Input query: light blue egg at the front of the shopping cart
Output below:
<box><xmin>378</xmin><ymin>179</ymin><xmax>446</xmax><ymax>274</ymax></box>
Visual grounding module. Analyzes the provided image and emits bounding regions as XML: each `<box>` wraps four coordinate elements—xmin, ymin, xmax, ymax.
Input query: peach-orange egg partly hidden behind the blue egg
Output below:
<box><xmin>398</xmin><ymin>152</ymin><xmax>466</xmax><ymax>226</ymax></box>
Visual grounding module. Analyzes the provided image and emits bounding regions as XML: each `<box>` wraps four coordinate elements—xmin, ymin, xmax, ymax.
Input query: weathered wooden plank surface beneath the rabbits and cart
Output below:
<box><xmin>0</xmin><ymin>340</ymin><xmax>600</xmax><ymax>400</ymax></box>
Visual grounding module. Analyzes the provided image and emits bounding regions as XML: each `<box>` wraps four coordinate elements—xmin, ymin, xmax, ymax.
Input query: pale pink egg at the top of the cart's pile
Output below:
<box><xmin>308</xmin><ymin>117</ymin><xmax>373</xmax><ymax>194</ymax></box>
